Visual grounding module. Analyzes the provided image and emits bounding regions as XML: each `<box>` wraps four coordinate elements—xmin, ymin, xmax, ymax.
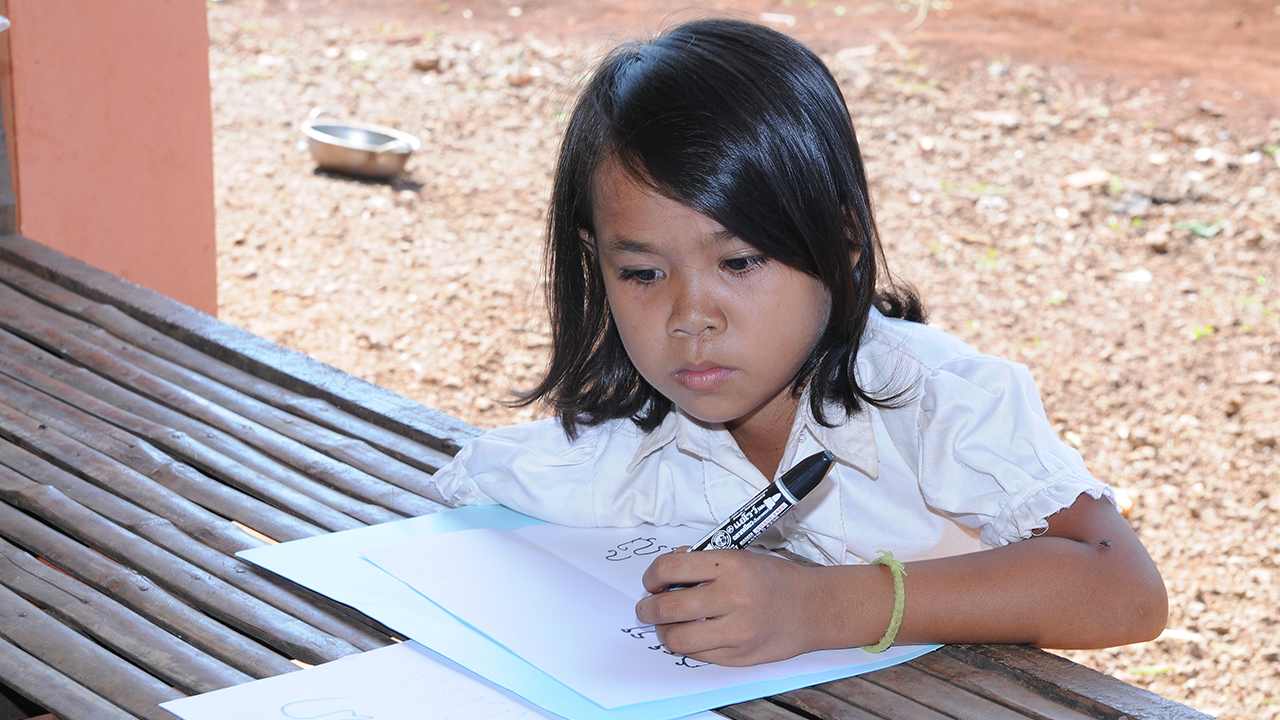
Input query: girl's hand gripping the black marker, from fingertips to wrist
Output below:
<box><xmin>636</xmin><ymin>550</ymin><xmax>892</xmax><ymax>665</ymax></box>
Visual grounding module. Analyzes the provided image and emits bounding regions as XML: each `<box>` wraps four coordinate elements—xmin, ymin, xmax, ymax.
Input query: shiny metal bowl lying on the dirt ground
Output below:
<box><xmin>302</xmin><ymin>110</ymin><xmax>421</xmax><ymax>178</ymax></box>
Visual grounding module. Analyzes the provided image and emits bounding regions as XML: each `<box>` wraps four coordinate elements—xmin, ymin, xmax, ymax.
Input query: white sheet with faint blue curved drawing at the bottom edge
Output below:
<box><xmin>160</xmin><ymin>642</ymin><xmax>557</xmax><ymax>720</ymax></box>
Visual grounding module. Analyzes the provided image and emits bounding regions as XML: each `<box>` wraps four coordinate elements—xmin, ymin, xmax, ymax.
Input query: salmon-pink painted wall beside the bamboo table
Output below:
<box><xmin>0</xmin><ymin>0</ymin><xmax>218</xmax><ymax>314</ymax></box>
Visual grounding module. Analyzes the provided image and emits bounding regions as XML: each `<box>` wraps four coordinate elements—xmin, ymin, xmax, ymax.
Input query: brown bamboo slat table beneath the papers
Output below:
<box><xmin>0</xmin><ymin>234</ymin><xmax>1206</xmax><ymax>720</ymax></box>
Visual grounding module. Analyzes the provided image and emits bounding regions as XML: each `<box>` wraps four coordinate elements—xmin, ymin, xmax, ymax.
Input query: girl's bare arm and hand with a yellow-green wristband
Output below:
<box><xmin>636</xmin><ymin>495</ymin><xmax>1169</xmax><ymax>665</ymax></box>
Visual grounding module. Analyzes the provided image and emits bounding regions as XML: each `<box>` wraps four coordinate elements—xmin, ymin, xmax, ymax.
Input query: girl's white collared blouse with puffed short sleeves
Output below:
<box><xmin>430</xmin><ymin>310</ymin><xmax>1114</xmax><ymax>564</ymax></box>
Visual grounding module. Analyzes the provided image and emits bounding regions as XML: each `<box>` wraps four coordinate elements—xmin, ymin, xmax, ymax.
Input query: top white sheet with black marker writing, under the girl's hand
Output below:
<box><xmin>364</xmin><ymin>515</ymin><xmax>931</xmax><ymax>708</ymax></box>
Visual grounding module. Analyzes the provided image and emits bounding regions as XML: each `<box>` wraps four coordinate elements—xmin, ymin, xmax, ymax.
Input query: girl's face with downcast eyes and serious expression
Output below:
<box><xmin>591</xmin><ymin>163</ymin><xmax>831</xmax><ymax>439</ymax></box>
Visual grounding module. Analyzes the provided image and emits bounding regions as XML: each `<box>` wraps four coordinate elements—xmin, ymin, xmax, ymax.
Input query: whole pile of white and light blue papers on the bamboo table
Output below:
<box><xmin>164</xmin><ymin>506</ymin><xmax>936</xmax><ymax>720</ymax></box>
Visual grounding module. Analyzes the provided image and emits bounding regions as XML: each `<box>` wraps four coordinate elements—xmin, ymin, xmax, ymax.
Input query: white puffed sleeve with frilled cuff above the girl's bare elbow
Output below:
<box><xmin>919</xmin><ymin>355</ymin><xmax>1114</xmax><ymax>547</ymax></box>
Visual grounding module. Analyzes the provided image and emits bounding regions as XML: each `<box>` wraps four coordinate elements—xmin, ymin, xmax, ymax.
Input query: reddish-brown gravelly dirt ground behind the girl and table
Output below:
<box><xmin>209</xmin><ymin>0</ymin><xmax>1280</xmax><ymax>717</ymax></box>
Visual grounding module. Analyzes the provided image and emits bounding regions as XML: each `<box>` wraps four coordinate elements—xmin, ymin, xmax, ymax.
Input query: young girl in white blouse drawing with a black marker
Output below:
<box><xmin>424</xmin><ymin>20</ymin><xmax>1167</xmax><ymax>665</ymax></box>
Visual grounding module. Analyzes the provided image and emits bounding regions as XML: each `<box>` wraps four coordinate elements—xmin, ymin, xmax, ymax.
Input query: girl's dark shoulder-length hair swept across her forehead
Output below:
<box><xmin>520</xmin><ymin>19</ymin><xmax>924</xmax><ymax>437</ymax></box>
